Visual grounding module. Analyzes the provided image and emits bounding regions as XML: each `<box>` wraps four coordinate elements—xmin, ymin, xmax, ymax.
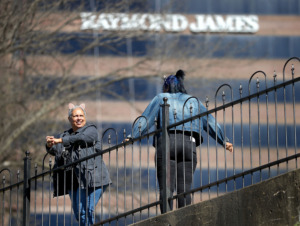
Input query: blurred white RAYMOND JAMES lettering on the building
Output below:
<box><xmin>80</xmin><ymin>12</ymin><xmax>259</xmax><ymax>33</ymax></box>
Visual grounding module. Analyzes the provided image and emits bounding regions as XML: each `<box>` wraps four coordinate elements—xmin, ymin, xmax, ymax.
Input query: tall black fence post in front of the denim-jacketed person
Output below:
<box><xmin>161</xmin><ymin>97</ymin><xmax>171</xmax><ymax>213</ymax></box>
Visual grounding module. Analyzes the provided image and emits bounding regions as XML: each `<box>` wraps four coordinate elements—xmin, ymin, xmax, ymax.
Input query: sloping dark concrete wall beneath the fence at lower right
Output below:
<box><xmin>133</xmin><ymin>169</ymin><xmax>300</xmax><ymax>226</ymax></box>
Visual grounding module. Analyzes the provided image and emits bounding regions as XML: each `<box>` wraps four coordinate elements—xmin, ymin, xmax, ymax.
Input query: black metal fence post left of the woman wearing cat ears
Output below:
<box><xmin>23</xmin><ymin>151</ymin><xmax>31</xmax><ymax>226</ymax></box>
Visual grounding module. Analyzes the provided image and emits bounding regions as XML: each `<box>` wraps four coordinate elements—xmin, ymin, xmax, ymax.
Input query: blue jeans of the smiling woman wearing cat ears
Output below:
<box><xmin>69</xmin><ymin>185</ymin><xmax>108</xmax><ymax>226</ymax></box>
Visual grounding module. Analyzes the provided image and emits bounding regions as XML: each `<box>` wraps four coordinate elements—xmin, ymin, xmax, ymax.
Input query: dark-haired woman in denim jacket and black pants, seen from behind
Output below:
<box><xmin>132</xmin><ymin>70</ymin><xmax>233</xmax><ymax>213</ymax></box>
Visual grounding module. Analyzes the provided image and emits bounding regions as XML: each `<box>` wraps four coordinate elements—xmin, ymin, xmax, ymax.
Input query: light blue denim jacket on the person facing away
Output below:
<box><xmin>131</xmin><ymin>93</ymin><xmax>228</xmax><ymax>145</ymax></box>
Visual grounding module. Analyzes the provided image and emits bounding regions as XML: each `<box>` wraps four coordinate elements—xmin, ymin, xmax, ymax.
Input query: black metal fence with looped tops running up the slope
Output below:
<box><xmin>0</xmin><ymin>57</ymin><xmax>300</xmax><ymax>225</ymax></box>
